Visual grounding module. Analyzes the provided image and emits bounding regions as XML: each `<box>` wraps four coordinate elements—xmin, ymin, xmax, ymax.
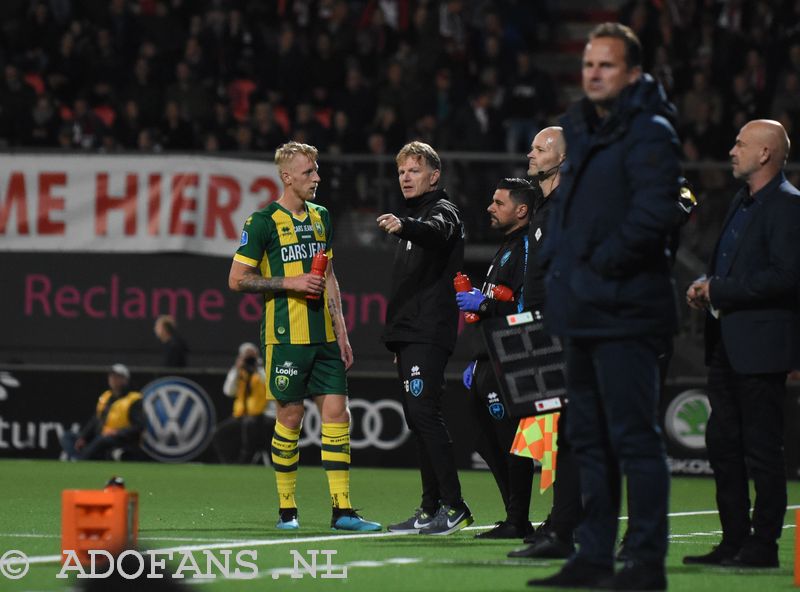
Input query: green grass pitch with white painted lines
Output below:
<box><xmin>0</xmin><ymin>460</ymin><xmax>800</xmax><ymax>592</ymax></box>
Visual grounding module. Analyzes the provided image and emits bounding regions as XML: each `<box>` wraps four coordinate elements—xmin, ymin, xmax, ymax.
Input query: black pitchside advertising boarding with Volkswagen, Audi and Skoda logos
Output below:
<box><xmin>0</xmin><ymin>366</ymin><xmax>800</xmax><ymax>479</ymax></box>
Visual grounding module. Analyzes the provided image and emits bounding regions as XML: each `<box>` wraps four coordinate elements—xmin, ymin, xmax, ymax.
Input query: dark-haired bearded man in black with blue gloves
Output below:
<box><xmin>456</xmin><ymin>179</ymin><xmax>539</xmax><ymax>539</ymax></box>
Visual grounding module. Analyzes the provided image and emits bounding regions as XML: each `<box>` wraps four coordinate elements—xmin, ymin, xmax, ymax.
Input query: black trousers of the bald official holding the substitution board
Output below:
<box><xmin>549</xmin><ymin>406</ymin><xmax>583</xmax><ymax>542</ymax></box>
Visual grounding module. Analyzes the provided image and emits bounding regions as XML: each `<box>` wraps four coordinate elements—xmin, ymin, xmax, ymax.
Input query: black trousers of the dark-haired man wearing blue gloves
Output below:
<box><xmin>469</xmin><ymin>360</ymin><xmax>534</xmax><ymax>526</ymax></box>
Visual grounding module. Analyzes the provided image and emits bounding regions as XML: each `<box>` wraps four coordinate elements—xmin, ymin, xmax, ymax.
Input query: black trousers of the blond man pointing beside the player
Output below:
<box><xmin>394</xmin><ymin>343</ymin><xmax>462</xmax><ymax>513</ymax></box>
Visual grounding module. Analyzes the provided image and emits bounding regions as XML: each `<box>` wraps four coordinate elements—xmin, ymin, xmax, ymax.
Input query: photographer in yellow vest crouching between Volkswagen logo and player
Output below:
<box><xmin>214</xmin><ymin>343</ymin><xmax>275</xmax><ymax>464</ymax></box>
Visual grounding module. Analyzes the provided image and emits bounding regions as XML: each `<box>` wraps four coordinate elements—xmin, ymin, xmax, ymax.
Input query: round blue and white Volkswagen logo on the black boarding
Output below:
<box><xmin>142</xmin><ymin>376</ymin><xmax>217</xmax><ymax>462</ymax></box>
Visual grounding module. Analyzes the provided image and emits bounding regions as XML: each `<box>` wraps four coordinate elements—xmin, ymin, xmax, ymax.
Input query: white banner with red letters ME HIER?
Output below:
<box><xmin>0</xmin><ymin>154</ymin><xmax>280</xmax><ymax>257</ymax></box>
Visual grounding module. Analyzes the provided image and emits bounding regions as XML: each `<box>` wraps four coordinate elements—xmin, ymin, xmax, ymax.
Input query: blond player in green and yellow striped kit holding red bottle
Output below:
<box><xmin>228</xmin><ymin>142</ymin><xmax>381</xmax><ymax>532</ymax></box>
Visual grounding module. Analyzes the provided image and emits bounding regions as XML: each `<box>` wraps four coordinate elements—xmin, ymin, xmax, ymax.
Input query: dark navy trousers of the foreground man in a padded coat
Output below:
<box><xmin>566</xmin><ymin>337</ymin><xmax>669</xmax><ymax>567</ymax></box>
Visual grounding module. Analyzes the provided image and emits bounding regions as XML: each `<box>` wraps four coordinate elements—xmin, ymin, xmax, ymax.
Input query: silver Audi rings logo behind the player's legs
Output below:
<box><xmin>299</xmin><ymin>399</ymin><xmax>411</xmax><ymax>450</ymax></box>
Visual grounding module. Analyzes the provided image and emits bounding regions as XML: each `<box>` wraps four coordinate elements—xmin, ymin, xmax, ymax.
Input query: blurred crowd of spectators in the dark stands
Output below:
<box><xmin>0</xmin><ymin>0</ymin><xmax>800</xmax><ymax>160</ymax></box>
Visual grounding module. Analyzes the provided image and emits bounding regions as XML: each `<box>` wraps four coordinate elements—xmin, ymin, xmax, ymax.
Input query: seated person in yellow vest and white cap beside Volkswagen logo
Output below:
<box><xmin>61</xmin><ymin>364</ymin><xmax>146</xmax><ymax>460</ymax></box>
